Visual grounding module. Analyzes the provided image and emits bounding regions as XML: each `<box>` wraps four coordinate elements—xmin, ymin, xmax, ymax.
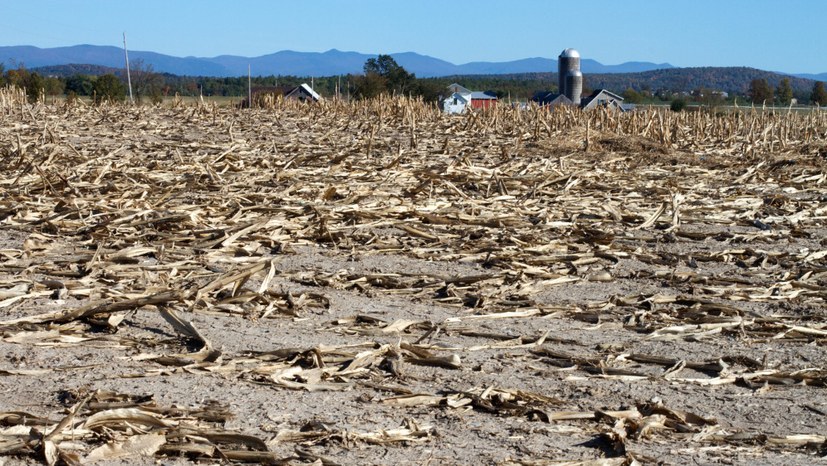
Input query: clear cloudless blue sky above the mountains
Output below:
<box><xmin>0</xmin><ymin>0</ymin><xmax>827</xmax><ymax>73</ymax></box>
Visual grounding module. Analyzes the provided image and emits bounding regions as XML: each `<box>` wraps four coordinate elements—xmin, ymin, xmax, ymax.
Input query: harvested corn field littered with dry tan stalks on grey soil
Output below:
<box><xmin>0</xmin><ymin>91</ymin><xmax>827</xmax><ymax>465</ymax></box>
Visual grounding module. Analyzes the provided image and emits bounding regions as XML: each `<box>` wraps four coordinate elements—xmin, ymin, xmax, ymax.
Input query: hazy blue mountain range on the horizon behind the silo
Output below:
<box><xmin>0</xmin><ymin>45</ymin><xmax>672</xmax><ymax>78</ymax></box>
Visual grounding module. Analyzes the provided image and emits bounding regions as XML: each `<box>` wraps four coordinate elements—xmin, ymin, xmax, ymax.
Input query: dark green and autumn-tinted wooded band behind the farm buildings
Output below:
<box><xmin>0</xmin><ymin>55</ymin><xmax>827</xmax><ymax>106</ymax></box>
